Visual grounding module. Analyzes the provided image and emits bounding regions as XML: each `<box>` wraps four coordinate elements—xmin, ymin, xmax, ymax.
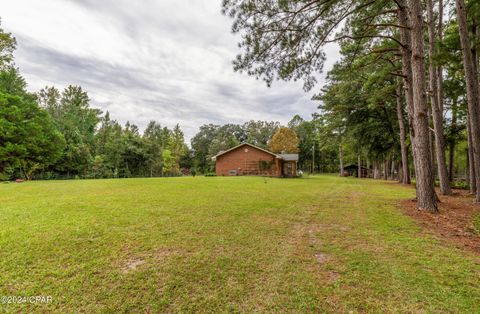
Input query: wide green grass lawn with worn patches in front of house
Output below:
<box><xmin>0</xmin><ymin>176</ymin><xmax>480</xmax><ymax>313</ymax></box>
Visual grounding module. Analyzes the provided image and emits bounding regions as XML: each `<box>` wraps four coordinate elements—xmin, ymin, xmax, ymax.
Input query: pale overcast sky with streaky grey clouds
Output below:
<box><xmin>0</xmin><ymin>0</ymin><xmax>338</xmax><ymax>140</ymax></box>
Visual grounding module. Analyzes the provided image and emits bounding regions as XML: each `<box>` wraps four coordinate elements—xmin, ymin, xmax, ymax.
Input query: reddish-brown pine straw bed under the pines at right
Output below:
<box><xmin>400</xmin><ymin>190</ymin><xmax>480</xmax><ymax>255</ymax></box>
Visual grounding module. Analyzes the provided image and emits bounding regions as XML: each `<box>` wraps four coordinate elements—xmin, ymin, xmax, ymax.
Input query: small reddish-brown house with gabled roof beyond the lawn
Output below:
<box><xmin>212</xmin><ymin>143</ymin><xmax>298</xmax><ymax>177</ymax></box>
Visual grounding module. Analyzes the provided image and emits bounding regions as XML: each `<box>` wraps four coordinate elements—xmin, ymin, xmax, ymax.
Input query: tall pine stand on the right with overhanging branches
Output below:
<box><xmin>223</xmin><ymin>0</ymin><xmax>480</xmax><ymax>212</ymax></box>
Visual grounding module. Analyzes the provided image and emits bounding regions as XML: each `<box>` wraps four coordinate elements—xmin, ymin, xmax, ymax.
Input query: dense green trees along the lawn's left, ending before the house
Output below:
<box><xmin>0</xmin><ymin>22</ymin><xmax>188</xmax><ymax>180</ymax></box>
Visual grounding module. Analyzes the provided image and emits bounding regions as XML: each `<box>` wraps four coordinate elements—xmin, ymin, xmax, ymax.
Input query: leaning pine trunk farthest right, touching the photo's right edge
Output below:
<box><xmin>456</xmin><ymin>0</ymin><xmax>480</xmax><ymax>203</ymax></box>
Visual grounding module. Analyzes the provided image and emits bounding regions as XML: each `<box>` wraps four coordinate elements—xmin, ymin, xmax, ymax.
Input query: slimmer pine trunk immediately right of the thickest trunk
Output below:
<box><xmin>427</xmin><ymin>0</ymin><xmax>452</xmax><ymax>195</ymax></box>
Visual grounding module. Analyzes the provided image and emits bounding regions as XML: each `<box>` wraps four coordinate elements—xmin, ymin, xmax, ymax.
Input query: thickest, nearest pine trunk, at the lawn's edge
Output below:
<box><xmin>408</xmin><ymin>0</ymin><xmax>438</xmax><ymax>212</ymax></box>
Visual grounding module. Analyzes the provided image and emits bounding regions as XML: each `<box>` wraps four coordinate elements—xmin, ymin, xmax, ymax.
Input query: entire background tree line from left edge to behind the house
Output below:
<box><xmin>0</xmin><ymin>20</ymin><xmax>337</xmax><ymax>180</ymax></box>
